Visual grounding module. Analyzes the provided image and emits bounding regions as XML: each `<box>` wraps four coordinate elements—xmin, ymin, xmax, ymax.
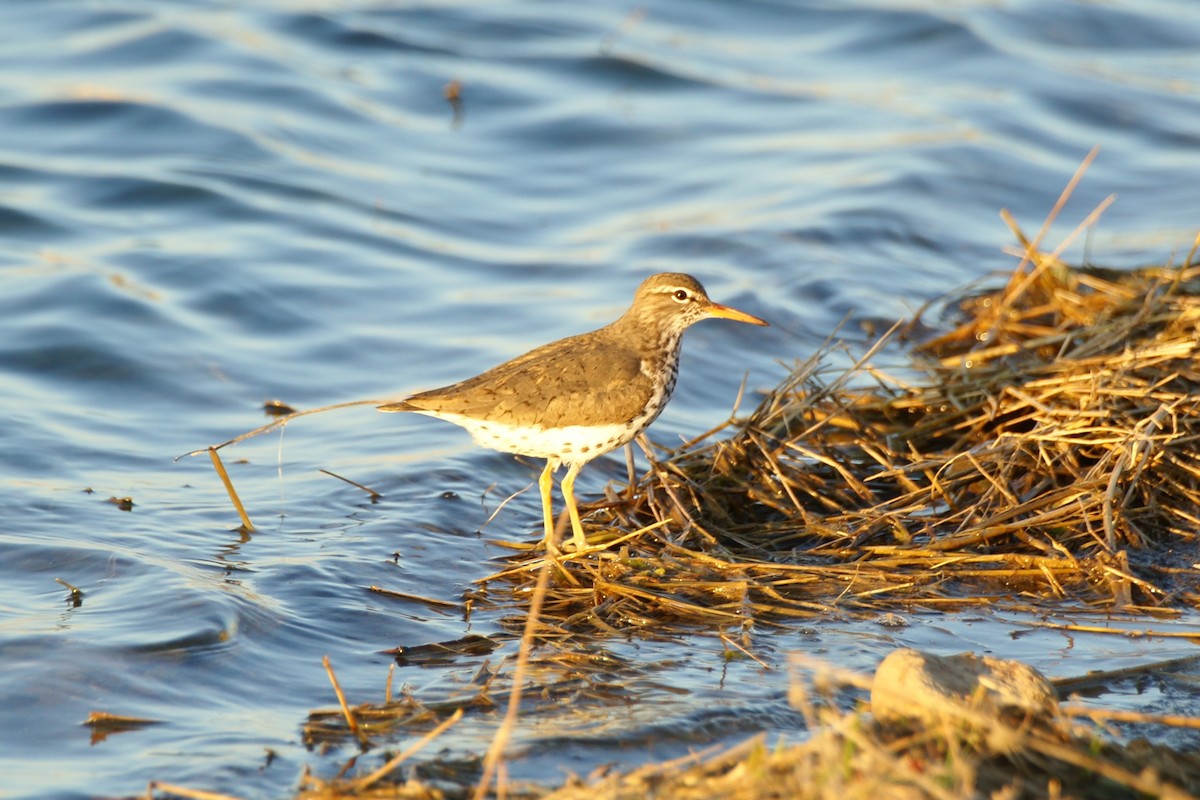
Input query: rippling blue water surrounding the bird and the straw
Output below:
<box><xmin>0</xmin><ymin>0</ymin><xmax>1200</xmax><ymax>798</ymax></box>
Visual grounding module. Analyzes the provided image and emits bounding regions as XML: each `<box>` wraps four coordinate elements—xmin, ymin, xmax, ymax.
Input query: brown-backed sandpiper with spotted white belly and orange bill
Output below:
<box><xmin>378</xmin><ymin>272</ymin><xmax>767</xmax><ymax>554</ymax></box>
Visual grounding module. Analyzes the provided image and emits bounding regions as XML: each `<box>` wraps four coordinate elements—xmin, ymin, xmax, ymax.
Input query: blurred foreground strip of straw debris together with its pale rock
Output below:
<box><xmin>276</xmin><ymin>650</ymin><xmax>1200</xmax><ymax>800</ymax></box>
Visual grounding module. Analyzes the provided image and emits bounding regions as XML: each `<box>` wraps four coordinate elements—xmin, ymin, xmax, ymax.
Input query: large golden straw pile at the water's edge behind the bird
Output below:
<box><xmin>488</xmin><ymin>247</ymin><xmax>1200</xmax><ymax>633</ymax></box>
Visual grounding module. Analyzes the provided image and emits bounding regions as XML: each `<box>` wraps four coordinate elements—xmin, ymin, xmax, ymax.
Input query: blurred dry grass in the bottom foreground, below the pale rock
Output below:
<box><xmin>542</xmin><ymin>712</ymin><xmax>1200</xmax><ymax>800</ymax></box>
